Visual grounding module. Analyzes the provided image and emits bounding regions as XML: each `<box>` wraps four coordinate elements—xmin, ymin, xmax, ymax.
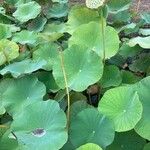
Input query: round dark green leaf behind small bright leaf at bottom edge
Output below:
<box><xmin>70</xmin><ymin>108</ymin><xmax>114</xmax><ymax>148</ymax></box>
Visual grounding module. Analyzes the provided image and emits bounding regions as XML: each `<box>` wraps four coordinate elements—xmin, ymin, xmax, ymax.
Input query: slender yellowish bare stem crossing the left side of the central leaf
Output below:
<box><xmin>59</xmin><ymin>50</ymin><xmax>70</xmax><ymax>130</ymax></box>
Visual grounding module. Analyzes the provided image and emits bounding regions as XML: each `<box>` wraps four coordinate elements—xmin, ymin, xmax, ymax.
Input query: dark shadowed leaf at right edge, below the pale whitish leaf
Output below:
<box><xmin>129</xmin><ymin>53</ymin><xmax>150</xmax><ymax>72</ymax></box>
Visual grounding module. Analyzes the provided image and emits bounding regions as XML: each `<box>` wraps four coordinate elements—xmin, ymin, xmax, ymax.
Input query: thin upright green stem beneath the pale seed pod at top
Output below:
<box><xmin>101</xmin><ymin>9</ymin><xmax>106</xmax><ymax>64</ymax></box>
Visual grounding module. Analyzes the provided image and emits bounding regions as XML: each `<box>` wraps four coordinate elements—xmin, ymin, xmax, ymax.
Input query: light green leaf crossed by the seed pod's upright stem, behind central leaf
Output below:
<box><xmin>69</xmin><ymin>22</ymin><xmax>119</xmax><ymax>58</ymax></box>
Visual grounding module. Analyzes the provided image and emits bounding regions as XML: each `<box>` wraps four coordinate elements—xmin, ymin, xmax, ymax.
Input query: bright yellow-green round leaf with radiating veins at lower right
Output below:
<box><xmin>98</xmin><ymin>86</ymin><xmax>143</xmax><ymax>132</ymax></box>
